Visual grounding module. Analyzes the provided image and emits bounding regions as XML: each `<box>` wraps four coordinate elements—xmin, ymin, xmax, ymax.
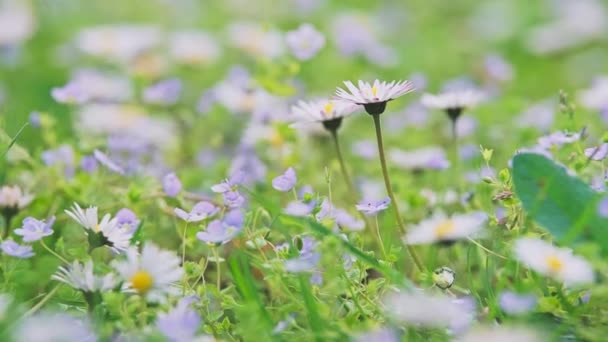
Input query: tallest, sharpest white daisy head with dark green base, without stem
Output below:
<box><xmin>336</xmin><ymin>80</ymin><xmax>414</xmax><ymax>115</ymax></box>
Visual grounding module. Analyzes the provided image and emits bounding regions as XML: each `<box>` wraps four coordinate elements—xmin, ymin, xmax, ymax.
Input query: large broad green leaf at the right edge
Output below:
<box><xmin>513</xmin><ymin>153</ymin><xmax>608</xmax><ymax>250</ymax></box>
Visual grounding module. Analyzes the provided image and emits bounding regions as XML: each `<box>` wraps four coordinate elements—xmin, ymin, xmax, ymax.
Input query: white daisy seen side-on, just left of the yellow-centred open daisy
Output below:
<box><xmin>52</xmin><ymin>260</ymin><xmax>116</xmax><ymax>292</ymax></box>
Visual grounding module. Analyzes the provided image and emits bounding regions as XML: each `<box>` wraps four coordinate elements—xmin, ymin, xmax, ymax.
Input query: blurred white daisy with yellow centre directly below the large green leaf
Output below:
<box><xmin>513</xmin><ymin>238</ymin><xmax>595</xmax><ymax>285</ymax></box>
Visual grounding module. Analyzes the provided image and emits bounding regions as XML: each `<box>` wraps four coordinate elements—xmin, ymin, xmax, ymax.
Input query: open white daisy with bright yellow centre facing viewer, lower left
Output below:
<box><xmin>112</xmin><ymin>243</ymin><xmax>183</xmax><ymax>302</ymax></box>
